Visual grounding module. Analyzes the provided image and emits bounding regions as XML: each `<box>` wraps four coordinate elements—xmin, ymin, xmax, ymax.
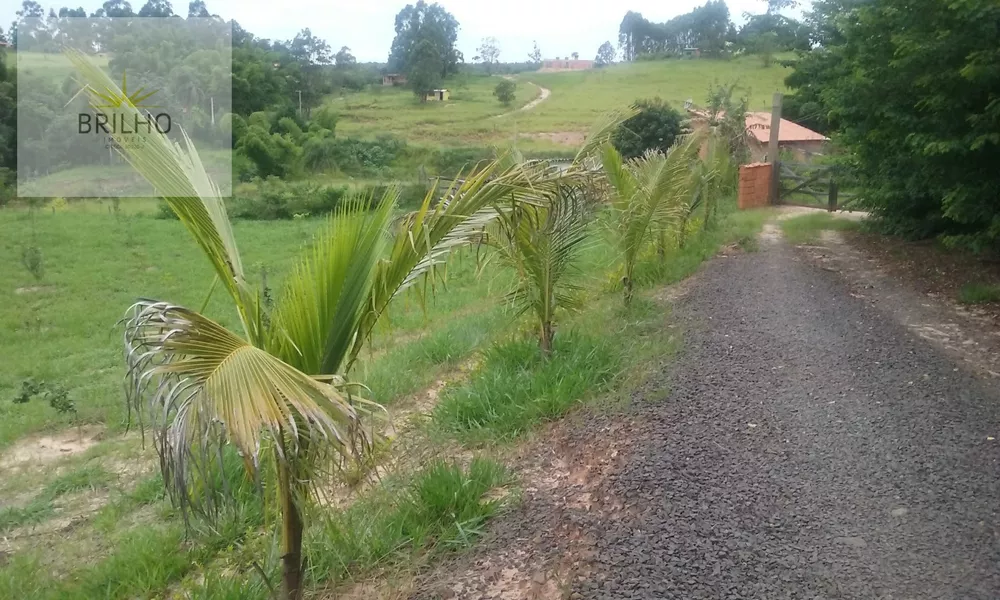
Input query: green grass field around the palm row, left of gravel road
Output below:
<box><xmin>0</xmin><ymin>191</ymin><xmax>766</xmax><ymax>599</ymax></box>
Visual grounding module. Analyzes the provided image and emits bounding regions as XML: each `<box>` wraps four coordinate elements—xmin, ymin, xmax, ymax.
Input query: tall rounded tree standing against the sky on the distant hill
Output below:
<box><xmin>389</xmin><ymin>0</ymin><xmax>462</xmax><ymax>79</ymax></box>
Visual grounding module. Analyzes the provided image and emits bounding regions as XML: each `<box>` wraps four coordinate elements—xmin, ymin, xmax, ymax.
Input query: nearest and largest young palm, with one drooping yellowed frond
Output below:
<box><xmin>69</xmin><ymin>52</ymin><xmax>565</xmax><ymax>599</ymax></box>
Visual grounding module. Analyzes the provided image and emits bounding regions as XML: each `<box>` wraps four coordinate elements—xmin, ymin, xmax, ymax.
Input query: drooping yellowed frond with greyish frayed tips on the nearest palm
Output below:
<box><xmin>125</xmin><ymin>300</ymin><xmax>363</xmax><ymax>514</ymax></box>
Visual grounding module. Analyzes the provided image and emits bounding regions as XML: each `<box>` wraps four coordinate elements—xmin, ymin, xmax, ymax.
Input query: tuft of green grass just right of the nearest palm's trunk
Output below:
<box><xmin>306</xmin><ymin>458</ymin><xmax>511</xmax><ymax>583</ymax></box>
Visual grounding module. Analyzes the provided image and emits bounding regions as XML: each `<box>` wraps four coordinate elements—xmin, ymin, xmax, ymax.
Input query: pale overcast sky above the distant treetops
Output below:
<box><xmin>0</xmin><ymin>0</ymin><xmax>796</xmax><ymax>62</ymax></box>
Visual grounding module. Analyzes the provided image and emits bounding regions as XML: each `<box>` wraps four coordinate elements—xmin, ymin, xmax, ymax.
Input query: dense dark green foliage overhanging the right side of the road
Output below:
<box><xmin>789</xmin><ymin>0</ymin><xmax>1000</xmax><ymax>249</ymax></box>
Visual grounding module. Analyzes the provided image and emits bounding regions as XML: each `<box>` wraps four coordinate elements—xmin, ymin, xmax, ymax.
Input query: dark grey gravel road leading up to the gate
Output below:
<box><xmin>417</xmin><ymin>224</ymin><xmax>1000</xmax><ymax>600</ymax></box>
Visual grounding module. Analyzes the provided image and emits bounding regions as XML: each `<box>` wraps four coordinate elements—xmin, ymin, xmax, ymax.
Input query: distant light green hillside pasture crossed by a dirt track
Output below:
<box><xmin>331</xmin><ymin>56</ymin><xmax>789</xmax><ymax>150</ymax></box>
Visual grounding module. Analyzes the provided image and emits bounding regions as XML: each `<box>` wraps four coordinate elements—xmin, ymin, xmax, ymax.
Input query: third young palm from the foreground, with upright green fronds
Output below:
<box><xmin>602</xmin><ymin>135</ymin><xmax>702</xmax><ymax>305</ymax></box>
